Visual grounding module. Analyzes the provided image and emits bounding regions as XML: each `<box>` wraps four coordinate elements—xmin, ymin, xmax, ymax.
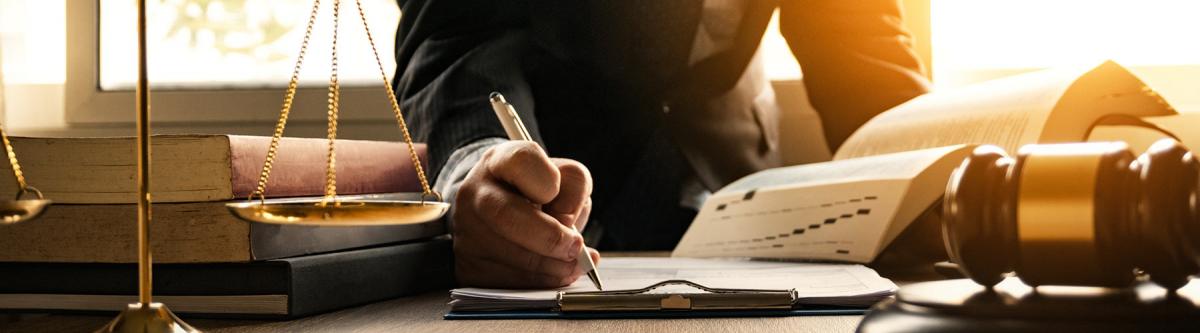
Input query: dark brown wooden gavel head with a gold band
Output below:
<box><xmin>942</xmin><ymin>139</ymin><xmax>1200</xmax><ymax>289</ymax></box>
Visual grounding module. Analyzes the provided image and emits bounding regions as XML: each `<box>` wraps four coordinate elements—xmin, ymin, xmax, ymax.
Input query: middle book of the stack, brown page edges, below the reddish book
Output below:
<box><xmin>0</xmin><ymin>198</ymin><xmax>446</xmax><ymax>264</ymax></box>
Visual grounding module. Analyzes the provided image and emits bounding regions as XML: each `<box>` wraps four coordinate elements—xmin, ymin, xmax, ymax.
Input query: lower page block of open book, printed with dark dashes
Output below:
<box><xmin>672</xmin><ymin>145</ymin><xmax>972</xmax><ymax>262</ymax></box>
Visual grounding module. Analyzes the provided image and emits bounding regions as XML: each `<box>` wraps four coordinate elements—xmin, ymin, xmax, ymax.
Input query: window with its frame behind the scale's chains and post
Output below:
<box><xmin>64</xmin><ymin>0</ymin><xmax>400</xmax><ymax>127</ymax></box>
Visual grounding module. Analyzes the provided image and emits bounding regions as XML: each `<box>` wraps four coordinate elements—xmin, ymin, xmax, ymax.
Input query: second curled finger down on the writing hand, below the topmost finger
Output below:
<box><xmin>472</xmin><ymin>182</ymin><xmax>583</xmax><ymax>261</ymax></box>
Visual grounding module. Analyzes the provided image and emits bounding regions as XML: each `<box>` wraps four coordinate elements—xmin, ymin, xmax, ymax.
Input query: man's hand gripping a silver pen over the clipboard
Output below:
<box><xmin>450</xmin><ymin>141</ymin><xmax>600</xmax><ymax>287</ymax></box>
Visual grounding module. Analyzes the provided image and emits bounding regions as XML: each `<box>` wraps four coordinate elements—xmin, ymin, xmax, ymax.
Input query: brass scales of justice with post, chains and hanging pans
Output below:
<box><xmin>0</xmin><ymin>0</ymin><xmax>450</xmax><ymax>332</ymax></box>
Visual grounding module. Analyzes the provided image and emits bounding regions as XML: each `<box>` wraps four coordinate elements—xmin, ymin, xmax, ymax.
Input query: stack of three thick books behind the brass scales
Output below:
<box><xmin>0</xmin><ymin>135</ymin><xmax>454</xmax><ymax>317</ymax></box>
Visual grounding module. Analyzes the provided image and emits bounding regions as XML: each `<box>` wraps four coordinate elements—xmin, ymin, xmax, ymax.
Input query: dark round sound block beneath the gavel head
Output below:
<box><xmin>857</xmin><ymin>278</ymin><xmax>1200</xmax><ymax>333</ymax></box>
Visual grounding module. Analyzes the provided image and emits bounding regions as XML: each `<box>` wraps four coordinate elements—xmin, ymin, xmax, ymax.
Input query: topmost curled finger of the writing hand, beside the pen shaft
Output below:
<box><xmin>481</xmin><ymin>141</ymin><xmax>560</xmax><ymax>204</ymax></box>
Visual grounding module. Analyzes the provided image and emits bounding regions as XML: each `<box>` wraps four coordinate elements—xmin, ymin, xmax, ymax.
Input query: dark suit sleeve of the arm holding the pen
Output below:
<box><xmin>392</xmin><ymin>0</ymin><xmax>539</xmax><ymax>178</ymax></box>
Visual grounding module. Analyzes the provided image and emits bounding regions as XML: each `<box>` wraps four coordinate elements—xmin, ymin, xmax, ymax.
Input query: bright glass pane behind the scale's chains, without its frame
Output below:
<box><xmin>100</xmin><ymin>0</ymin><xmax>400</xmax><ymax>90</ymax></box>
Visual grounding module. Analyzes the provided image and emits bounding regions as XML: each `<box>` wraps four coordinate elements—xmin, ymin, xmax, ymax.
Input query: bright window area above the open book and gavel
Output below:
<box><xmin>930</xmin><ymin>0</ymin><xmax>1200</xmax><ymax>111</ymax></box>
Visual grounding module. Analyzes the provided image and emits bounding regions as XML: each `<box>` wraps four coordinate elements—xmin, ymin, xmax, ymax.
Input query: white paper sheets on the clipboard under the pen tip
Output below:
<box><xmin>450</xmin><ymin>258</ymin><xmax>896</xmax><ymax>310</ymax></box>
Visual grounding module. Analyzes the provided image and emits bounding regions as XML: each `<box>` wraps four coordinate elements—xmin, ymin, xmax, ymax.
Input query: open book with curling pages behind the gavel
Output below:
<box><xmin>672</xmin><ymin>61</ymin><xmax>1185</xmax><ymax>262</ymax></box>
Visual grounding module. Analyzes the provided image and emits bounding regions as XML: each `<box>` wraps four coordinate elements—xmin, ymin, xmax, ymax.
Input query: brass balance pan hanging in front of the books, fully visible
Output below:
<box><xmin>226</xmin><ymin>195</ymin><xmax>450</xmax><ymax>226</ymax></box>
